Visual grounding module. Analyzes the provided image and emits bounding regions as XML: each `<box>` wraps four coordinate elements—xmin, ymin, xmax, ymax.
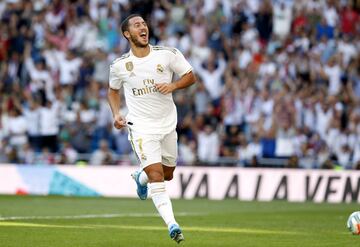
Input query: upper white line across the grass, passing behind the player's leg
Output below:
<box><xmin>0</xmin><ymin>212</ymin><xmax>206</xmax><ymax>221</ymax></box>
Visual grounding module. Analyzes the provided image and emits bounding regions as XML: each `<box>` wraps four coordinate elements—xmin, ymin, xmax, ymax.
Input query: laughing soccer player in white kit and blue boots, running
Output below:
<box><xmin>108</xmin><ymin>14</ymin><xmax>196</xmax><ymax>243</ymax></box>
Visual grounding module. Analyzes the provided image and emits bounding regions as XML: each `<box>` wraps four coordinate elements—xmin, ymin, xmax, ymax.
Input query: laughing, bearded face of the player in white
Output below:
<box><xmin>128</xmin><ymin>16</ymin><xmax>149</xmax><ymax>47</ymax></box>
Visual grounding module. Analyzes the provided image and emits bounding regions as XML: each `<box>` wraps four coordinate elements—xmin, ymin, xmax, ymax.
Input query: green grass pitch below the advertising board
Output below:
<box><xmin>0</xmin><ymin>196</ymin><xmax>360</xmax><ymax>247</ymax></box>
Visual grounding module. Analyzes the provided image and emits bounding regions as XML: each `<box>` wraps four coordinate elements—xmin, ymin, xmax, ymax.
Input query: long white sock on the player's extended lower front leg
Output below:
<box><xmin>148</xmin><ymin>182</ymin><xmax>177</xmax><ymax>228</ymax></box>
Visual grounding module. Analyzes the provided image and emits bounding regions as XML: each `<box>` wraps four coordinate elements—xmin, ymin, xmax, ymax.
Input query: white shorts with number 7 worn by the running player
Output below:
<box><xmin>129</xmin><ymin>129</ymin><xmax>177</xmax><ymax>169</ymax></box>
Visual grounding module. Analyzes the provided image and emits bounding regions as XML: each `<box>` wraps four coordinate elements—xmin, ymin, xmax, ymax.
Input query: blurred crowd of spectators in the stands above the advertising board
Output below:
<box><xmin>0</xmin><ymin>0</ymin><xmax>360</xmax><ymax>169</ymax></box>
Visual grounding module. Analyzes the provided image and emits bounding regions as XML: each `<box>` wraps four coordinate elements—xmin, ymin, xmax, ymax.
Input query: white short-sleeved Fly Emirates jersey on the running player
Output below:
<box><xmin>109</xmin><ymin>45</ymin><xmax>192</xmax><ymax>134</ymax></box>
